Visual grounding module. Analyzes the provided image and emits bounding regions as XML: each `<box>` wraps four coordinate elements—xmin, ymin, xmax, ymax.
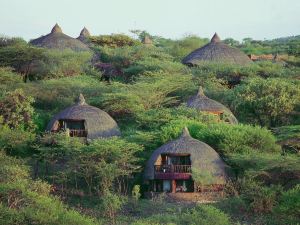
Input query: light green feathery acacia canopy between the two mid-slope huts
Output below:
<box><xmin>102</xmin><ymin>73</ymin><xmax>195</xmax><ymax>115</ymax></box>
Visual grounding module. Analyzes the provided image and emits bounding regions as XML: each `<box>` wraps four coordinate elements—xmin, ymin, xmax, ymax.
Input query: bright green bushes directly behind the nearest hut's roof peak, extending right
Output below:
<box><xmin>161</xmin><ymin>120</ymin><xmax>280</xmax><ymax>154</ymax></box>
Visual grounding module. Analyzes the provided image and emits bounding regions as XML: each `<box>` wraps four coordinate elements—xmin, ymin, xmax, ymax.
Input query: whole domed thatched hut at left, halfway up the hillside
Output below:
<box><xmin>47</xmin><ymin>94</ymin><xmax>121</xmax><ymax>139</ymax></box>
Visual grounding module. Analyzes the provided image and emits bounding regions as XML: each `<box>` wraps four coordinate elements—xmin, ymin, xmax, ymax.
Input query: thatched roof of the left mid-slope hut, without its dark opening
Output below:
<box><xmin>47</xmin><ymin>94</ymin><xmax>121</xmax><ymax>139</ymax></box>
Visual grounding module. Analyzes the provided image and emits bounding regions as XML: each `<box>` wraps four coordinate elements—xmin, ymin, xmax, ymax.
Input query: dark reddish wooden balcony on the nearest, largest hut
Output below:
<box><xmin>154</xmin><ymin>165</ymin><xmax>192</xmax><ymax>180</ymax></box>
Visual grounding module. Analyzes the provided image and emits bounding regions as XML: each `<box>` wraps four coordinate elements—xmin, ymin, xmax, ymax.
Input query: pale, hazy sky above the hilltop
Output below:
<box><xmin>0</xmin><ymin>0</ymin><xmax>300</xmax><ymax>40</ymax></box>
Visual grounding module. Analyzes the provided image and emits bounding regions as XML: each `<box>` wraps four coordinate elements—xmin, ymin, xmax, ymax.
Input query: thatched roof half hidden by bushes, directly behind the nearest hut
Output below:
<box><xmin>187</xmin><ymin>86</ymin><xmax>238</xmax><ymax>124</ymax></box>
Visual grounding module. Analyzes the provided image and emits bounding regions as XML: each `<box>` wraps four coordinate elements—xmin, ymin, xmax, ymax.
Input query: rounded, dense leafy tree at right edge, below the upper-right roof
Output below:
<box><xmin>232</xmin><ymin>78</ymin><xmax>300</xmax><ymax>127</ymax></box>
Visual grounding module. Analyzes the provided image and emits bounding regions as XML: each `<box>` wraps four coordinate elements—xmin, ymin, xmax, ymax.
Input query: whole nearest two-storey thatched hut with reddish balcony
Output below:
<box><xmin>144</xmin><ymin>127</ymin><xmax>227</xmax><ymax>193</ymax></box>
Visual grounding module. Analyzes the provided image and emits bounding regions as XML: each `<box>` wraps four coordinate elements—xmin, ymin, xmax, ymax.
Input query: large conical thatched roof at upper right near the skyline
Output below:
<box><xmin>182</xmin><ymin>33</ymin><xmax>251</xmax><ymax>66</ymax></box>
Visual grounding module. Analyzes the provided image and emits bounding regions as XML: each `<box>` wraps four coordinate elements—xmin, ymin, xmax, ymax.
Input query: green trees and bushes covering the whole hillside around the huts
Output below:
<box><xmin>0</xmin><ymin>30</ymin><xmax>300</xmax><ymax>225</ymax></box>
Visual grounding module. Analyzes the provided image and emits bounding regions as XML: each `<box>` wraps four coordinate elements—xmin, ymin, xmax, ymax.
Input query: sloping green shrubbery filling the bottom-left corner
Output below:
<box><xmin>0</xmin><ymin>151</ymin><xmax>96</xmax><ymax>225</ymax></box>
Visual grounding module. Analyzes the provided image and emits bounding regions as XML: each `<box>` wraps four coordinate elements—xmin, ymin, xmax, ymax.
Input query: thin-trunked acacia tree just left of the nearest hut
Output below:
<box><xmin>74</xmin><ymin>138</ymin><xmax>141</xmax><ymax>196</ymax></box>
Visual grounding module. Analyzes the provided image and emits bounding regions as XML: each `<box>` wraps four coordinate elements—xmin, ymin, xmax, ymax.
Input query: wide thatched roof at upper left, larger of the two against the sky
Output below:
<box><xmin>30</xmin><ymin>24</ymin><xmax>89</xmax><ymax>51</ymax></box>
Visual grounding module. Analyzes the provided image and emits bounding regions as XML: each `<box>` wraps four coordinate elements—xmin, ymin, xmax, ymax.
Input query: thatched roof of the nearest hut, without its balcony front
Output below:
<box><xmin>144</xmin><ymin>127</ymin><xmax>227</xmax><ymax>184</ymax></box>
